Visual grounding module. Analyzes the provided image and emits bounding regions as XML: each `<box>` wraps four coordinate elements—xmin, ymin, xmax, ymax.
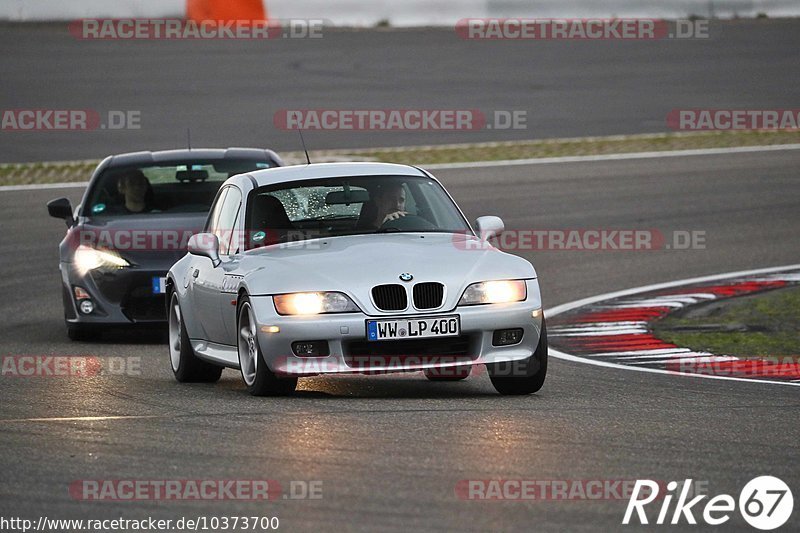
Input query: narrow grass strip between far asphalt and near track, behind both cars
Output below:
<box><xmin>0</xmin><ymin>131</ymin><xmax>800</xmax><ymax>185</ymax></box>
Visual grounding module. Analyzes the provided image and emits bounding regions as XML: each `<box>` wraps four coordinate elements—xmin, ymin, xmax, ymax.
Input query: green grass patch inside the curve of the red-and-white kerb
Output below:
<box><xmin>653</xmin><ymin>287</ymin><xmax>800</xmax><ymax>357</ymax></box>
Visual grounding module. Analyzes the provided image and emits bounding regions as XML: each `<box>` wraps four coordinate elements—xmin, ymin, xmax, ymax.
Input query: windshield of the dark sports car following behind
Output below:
<box><xmin>83</xmin><ymin>158</ymin><xmax>272</xmax><ymax>217</ymax></box>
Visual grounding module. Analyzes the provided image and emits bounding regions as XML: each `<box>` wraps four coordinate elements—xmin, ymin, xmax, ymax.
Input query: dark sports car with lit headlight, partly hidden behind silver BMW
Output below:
<box><xmin>47</xmin><ymin>148</ymin><xmax>282</xmax><ymax>340</ymax></box>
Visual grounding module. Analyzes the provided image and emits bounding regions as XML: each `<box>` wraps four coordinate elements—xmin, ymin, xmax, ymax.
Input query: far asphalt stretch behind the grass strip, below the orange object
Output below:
<box><xmin>0</xmin><ymin>19</ymin><xmax>800</xmax><ymax>162</ymax></box>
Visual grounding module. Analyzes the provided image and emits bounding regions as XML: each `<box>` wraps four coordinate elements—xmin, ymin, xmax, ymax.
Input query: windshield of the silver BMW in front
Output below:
<box><xmin>245</xmin><ymin>176</ymin><xmax>470</xmax><ymax>248</ymax></box>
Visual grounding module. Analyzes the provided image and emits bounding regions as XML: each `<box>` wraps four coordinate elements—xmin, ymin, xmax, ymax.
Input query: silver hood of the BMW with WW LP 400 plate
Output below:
<box><xmin>241</xmin><ymin>233</ymin><xmax>536</xmax><ymax>309</ymax></box>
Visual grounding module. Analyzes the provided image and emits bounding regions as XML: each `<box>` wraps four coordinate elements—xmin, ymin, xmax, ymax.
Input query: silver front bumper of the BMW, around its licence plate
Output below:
<box><xmin>250</xmin><ymin>280</ymin><xmax>542</xmax><ymax>376</ymax></box>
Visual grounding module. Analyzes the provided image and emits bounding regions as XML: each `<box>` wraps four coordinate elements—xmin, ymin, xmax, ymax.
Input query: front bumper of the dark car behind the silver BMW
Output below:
<box><xmin>59</xmin><ymin>263</ymin><xmax>171</xmax><ymax>325</ymax></box>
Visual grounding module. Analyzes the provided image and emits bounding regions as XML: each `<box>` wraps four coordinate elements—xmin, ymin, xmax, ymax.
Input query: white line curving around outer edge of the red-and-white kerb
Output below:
<box><xmin>544</xmin><ymin>264</ymin><xmax>800</xmax><ymax>386</ymax></box>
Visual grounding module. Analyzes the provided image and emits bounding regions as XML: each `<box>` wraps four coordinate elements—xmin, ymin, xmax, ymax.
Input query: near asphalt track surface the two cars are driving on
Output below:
<box><xmin>0</xmin><ymin>151</ymin><xmax>800</xmax><ymax>531</ymax></box>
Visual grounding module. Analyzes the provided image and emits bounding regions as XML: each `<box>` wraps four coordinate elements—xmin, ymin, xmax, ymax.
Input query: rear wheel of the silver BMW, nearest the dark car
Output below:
<box><xmin>168</xmin><ymin>292</ymin><xmax>222</xmax><ymax>383</ymax></box>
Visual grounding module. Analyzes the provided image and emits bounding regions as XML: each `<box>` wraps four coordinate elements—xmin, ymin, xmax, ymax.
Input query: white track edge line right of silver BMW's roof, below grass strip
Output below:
<box><xmin>420</xmin><ymin>144</ymin><xmax>800</xmax><ymax>170</ymax></box>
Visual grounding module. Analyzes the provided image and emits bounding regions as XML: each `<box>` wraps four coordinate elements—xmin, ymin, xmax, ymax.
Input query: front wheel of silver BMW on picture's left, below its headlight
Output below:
<box><xmin>241</xmin><ymin>296</ymin><xmax>297</xmax><ymax>396</ymax></box>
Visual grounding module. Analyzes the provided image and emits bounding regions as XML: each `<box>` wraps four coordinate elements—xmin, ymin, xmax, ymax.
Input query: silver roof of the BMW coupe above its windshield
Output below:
<box><xmin>248</xmin><ymin>162</ymin><xmax>430</xmax><ymax>187</ymax></box>
